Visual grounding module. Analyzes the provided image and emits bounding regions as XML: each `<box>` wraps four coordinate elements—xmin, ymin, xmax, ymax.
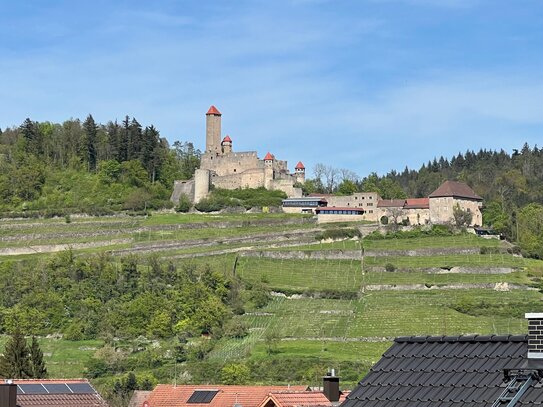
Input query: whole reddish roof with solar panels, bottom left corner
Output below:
<box><xmin>13</xmin><ymin>379</ymin><xmax>108</xmax><ymax>407</ymax></box>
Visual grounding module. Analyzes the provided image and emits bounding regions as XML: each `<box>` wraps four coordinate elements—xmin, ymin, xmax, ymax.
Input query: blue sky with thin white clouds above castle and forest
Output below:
<box><xmin>0</xmin><ymin>0</ymin><xmax>543</xmax><ymax>177</ymax></box>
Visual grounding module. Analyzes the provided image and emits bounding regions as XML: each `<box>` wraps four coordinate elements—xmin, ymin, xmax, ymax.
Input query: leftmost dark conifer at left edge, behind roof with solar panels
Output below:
<box><xmin>0</xmin><ymin>330</ymin><xmax>32</xmax><ymax>379</ymax></box>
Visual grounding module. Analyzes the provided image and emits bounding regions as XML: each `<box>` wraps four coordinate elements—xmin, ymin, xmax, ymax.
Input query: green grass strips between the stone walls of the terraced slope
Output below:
<box><xmin>0</xmin><ymin>214</ymin><xmax>543</xmax><ymax>386</ymax></box>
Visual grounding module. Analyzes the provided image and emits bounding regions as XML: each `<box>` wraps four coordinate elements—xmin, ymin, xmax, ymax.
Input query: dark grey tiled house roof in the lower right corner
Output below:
<box><xmin>341</xmin><ymin>335</ymin><xmax>543</xmax><ymax>407</ymax></box>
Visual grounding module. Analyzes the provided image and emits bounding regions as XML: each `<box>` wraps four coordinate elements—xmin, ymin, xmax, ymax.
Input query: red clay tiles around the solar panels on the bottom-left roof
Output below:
<box><xmin>13</xmin><ymin>379</ymin><xmax>108</xmax><ymax>407</ymax></box>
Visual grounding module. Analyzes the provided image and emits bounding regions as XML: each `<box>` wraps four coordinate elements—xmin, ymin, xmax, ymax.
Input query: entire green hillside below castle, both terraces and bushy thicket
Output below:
<box><xmin>0</xmin><ymin>214</ymin><xmax>543</xmax><ymax>404</ymax></box>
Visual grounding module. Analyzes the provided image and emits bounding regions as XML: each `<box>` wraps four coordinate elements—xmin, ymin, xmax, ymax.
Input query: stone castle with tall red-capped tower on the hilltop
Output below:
<box><xmin>171</xmin><ymin>106</ymin><xmax>305</xmax><ymax>204</ymax></box>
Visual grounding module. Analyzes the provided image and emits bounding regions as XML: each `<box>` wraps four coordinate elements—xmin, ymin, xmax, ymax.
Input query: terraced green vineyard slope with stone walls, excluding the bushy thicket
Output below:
<box><xmin>0</xmin><ymin>214</ymin><xmax>543</xmax><ymax>380</ymax></box>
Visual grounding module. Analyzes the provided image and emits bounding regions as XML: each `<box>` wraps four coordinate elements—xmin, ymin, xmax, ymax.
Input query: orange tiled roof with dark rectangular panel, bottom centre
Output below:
<box><xmin>143</xmin><ymin>384</ymin><xmax>306</xmax><ymax>407</ymax></box>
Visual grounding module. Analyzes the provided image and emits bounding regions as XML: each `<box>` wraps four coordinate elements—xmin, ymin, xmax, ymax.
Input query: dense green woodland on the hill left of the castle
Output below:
<box><xmin>0</xmin><ymin>115</ymin><xmax>200</xmax><ymax>214</ymax></box>
